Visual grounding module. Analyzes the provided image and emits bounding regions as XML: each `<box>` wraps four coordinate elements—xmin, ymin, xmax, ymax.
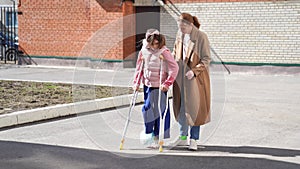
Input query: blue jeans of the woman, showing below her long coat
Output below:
<box><xmin>178</xmin><ymin>85</ymin><xmax>200</xmax><ymax>140</ymax></box>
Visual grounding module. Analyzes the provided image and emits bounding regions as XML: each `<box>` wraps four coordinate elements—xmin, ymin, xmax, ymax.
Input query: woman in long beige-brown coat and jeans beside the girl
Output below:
<box><xmin>173</xmin><ymin>13</ymin><xmax>211</xmax><ymax>150</ymax></box>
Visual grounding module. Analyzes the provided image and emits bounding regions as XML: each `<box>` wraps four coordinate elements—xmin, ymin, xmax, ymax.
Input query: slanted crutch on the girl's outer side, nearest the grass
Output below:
<box><xmin>120</xmin><ymin>60</ymin><xmax>144</xmax><ymax>150</ymax></box>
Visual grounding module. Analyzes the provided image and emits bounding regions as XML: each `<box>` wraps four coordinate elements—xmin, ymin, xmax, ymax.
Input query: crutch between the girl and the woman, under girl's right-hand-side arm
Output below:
<box><xmin>158</xmin><ymin>55</ymin><xmax>169</xmax><ymax>152</ymax></box>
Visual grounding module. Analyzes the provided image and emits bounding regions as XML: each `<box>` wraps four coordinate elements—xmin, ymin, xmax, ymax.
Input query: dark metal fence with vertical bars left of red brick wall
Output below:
<box><xmin>0</xmin><ymin>6</ymin><xmax>19</xmax><ymax>63</ymax></box>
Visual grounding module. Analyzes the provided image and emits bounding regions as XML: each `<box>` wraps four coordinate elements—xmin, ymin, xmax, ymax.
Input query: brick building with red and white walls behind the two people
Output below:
<box><xmin>18</xmin><ymin>0</ymin><xmax>300</xmax><ymax>66</ymax></box>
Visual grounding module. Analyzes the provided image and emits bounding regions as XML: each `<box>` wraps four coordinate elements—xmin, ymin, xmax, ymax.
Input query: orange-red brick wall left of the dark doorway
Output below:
<box><xmin>19</xmin><ymin>0</ymin><xmax>278</xmax><ymax>60</ymax></box>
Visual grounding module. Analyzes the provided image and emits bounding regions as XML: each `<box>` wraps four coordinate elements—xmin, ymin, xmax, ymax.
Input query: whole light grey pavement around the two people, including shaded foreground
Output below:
<box><xmin>0</xmin><ymin>64</ymin><xmax>300</xmax><ymax>169</ymax></box>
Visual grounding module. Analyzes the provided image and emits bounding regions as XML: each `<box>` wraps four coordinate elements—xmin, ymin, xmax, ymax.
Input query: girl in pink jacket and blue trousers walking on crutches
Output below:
<box><xmin>133</xmin><ymin>29</ymin><xmax>178</xmax><ymax>148</ymax></box>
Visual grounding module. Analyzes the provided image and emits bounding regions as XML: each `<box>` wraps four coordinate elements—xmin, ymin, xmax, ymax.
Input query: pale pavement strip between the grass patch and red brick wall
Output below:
<box><xmin>0</xmin><ymin>64</ymin><xmax>134</xmax><ymax>86</ymax></box>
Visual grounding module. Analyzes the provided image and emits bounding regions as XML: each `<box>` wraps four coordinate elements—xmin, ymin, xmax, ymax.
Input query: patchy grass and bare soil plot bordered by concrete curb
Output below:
<box><xmin>0</xmin><ymin>80</ymin><xmax>133</xmax><ymax>114</ymax></box>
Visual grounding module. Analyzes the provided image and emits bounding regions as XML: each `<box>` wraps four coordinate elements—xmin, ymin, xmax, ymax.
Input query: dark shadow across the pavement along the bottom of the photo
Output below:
<box><xmin>0</xmin><ymin>141</ymin><xmax>300</xmax><ymax>169</ymax></box>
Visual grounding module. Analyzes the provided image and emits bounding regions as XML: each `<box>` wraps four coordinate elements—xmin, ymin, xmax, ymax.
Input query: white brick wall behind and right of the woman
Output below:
<box><xmin>162</xmin><ymin>1</ymin><xmax>300</xmax><ymax>64</ymax></box>
